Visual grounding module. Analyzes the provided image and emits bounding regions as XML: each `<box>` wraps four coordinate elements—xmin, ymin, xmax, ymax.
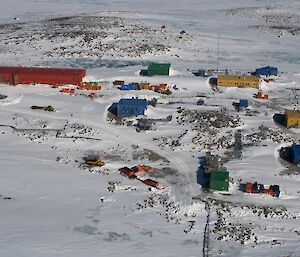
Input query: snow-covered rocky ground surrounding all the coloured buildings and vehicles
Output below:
<box><xmin>0</xmin><ymin>0</ymin><xmax>300</xmax><ymax>257</ymax></box>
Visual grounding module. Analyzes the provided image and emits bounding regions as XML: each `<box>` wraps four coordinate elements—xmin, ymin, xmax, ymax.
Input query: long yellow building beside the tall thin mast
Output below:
<box><xmin>217</xmin><ymin>75</ymin><xmax>260</xmax><ymax>89</ymax></box>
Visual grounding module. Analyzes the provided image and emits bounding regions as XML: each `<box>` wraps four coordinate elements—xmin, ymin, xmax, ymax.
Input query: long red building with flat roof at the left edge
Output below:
<box><xmin>0</xmin><ymin>67</ymin><xmax>86</xmax><ymax>86</ymax></box>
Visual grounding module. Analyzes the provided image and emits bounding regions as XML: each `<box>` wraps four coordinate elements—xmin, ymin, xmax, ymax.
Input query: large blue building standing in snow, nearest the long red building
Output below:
<box><xmin>116</xmin><ymin>98</ymin><xmax>148</xmax><ymax>117</ymax></box>
